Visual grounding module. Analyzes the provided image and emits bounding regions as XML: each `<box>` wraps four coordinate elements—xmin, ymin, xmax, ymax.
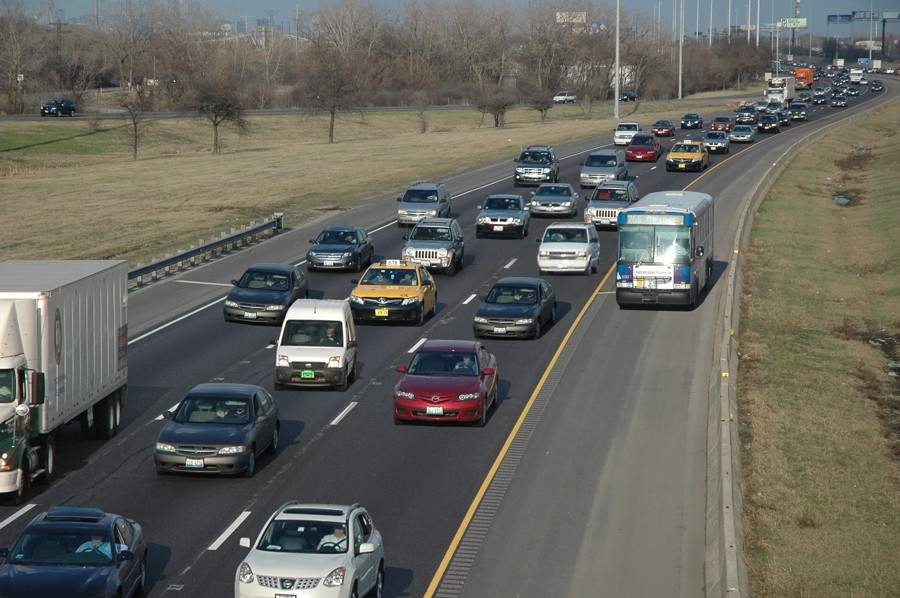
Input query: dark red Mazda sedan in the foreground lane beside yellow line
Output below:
<box><xmin>394</xmin><ymin>340</ymin><xmax>499</xmax><ymax>426</ymax></box>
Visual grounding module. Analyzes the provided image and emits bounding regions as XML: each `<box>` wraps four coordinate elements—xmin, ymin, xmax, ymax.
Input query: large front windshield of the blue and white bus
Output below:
<box><xmin>619</xmin><ymin>225</ymin><xmax>691</xmax><ymax>264</ymax></box>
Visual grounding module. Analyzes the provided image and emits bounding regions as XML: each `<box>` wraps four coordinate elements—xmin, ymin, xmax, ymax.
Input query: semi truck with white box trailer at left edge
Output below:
<box><xmin>0</xmin><ymin>260</ymin><xmax>128</xmax><ymax>503</ymax></box>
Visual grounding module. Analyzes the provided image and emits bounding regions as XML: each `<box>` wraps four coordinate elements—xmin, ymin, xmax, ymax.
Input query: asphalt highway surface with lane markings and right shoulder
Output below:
<box><xmin>0</xmin><ymin>81</ymin><xmax>897</xmax><ymax>597</ymax></box>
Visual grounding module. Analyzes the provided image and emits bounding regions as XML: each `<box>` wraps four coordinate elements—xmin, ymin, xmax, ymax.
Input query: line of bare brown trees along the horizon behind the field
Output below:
<box><xmin>0</xmin><ymin>0</ymin><xmax>770</xmax><ymax>138</ymax></box>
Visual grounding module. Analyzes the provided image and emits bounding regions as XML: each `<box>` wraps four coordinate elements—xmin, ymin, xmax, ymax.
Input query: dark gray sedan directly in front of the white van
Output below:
<box><xmin>153</xmin><ymin>382</ymin><xmax>281</xmax><ymax>477</ymax></box>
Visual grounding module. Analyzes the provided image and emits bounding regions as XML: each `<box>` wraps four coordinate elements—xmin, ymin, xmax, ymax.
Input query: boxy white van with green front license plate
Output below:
<box><xmin>272</xmin><ymin>299</ymin><xmax>357</xmax><ymax>390</ymax></box>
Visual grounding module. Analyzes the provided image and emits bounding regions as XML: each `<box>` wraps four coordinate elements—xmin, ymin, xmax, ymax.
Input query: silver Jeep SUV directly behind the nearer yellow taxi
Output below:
<box><xmin>403</xmin><ymin>218</ymin><xmax>466</xmax><ymax>276</ymax></box>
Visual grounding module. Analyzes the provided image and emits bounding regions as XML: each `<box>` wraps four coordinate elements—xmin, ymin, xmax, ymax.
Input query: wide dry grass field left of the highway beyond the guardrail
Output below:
<box><xmin>0</xmin><ymin>99</ymin><xmax>744</xmax><ymax>266</ymax></box>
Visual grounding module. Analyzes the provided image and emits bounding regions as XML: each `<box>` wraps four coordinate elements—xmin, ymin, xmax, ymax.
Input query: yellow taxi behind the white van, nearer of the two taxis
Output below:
<box><xmin>350</xmin><ymin>260</ymin><xmax>437</xmax><ymax>325</ymax></box>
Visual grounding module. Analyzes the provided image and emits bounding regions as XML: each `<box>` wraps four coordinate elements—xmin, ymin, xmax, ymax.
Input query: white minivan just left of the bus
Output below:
<box><xmin>535</xmin><ymin>222</ymin><xmax>600</xmax><ymax>276</ymax></box>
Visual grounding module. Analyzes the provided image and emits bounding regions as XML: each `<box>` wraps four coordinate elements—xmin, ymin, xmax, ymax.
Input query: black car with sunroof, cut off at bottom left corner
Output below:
<box><xmin>0</xmin><ymin>507</ymin><xmax>147</xmax><ymax>598</ymax></box>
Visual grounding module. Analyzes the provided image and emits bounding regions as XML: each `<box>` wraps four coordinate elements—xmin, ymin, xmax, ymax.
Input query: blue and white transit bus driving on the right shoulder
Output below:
<box><xmin>616</xmin><ymin>191</ymin><xmax>714</xmax><ymax>308</ymax></box>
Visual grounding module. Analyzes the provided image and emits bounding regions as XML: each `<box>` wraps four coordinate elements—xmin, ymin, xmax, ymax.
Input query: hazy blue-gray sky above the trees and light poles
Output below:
<box><xmin>24</xmin><ymin>0</ymin><xmax>900</xmax><ymax>39</ymax></box>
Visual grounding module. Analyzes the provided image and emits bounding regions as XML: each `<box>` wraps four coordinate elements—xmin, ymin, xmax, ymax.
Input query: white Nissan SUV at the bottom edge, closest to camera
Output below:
<box><xmin>234</xmin><ymin>501</ymin><xmax>384</xmax><ymax>598</ymax></box>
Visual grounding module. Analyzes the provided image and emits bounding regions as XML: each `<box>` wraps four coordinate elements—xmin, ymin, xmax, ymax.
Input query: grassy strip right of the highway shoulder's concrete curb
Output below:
<box><xmin>739</xmin><ymin>104</ymin><xmax>900</xmax><ymax>598</ymax></box>
